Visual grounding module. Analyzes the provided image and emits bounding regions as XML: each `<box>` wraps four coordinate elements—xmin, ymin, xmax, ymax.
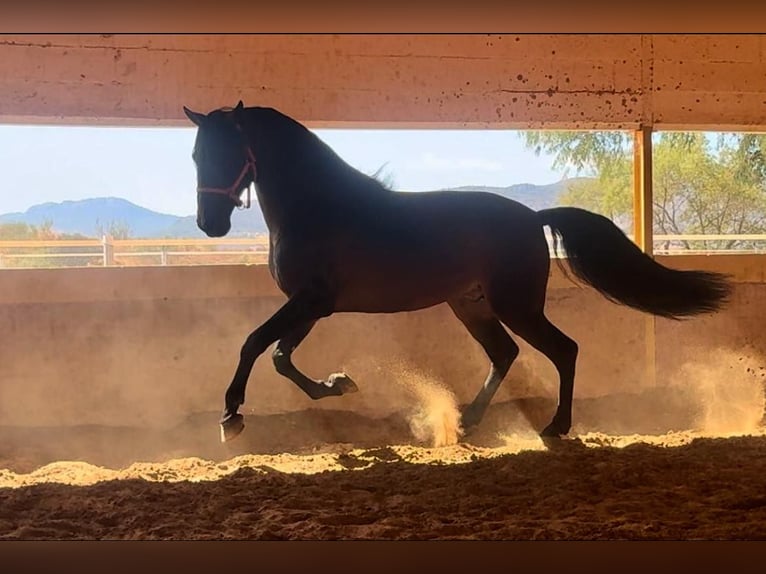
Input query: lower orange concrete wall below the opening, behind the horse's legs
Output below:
<box><xmin>0</xmin><ymin>256</ymin><xmax>766</xmax><ymax>427</ymax></box>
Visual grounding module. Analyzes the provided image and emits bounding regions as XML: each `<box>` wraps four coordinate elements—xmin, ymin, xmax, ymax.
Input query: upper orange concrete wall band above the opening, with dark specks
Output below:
<box><xmin>0</xmin><ymin>34</ymin><xmax>766</xmax><ymax>129</ymax></box>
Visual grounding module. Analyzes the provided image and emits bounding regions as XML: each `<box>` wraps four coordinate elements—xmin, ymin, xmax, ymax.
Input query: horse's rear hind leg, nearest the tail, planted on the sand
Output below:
<box><xmin>491</xmin><ymin>294</ymin><xmax>578</xmax><ymax>437</ymax></box>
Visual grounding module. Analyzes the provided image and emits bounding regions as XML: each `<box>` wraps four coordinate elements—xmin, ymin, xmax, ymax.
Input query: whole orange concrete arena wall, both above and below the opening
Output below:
<box><xmin>0</xmin><ymin>35</ymin><xmax>766</xmax><ymax>436</ymax></box>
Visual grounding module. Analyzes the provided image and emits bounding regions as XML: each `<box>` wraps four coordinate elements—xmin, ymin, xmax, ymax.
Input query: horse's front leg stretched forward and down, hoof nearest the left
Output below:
<box><xmin>220</xmin><ymin>292</ymin><xmax>333</xmax><ymax>442</ymax></box>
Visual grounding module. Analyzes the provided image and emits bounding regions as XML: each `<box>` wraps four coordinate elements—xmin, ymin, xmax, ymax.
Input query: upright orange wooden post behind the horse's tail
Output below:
<box><xmin>633</xmin><ymin>126</ymin><xmax>657</xmax><ymax>386</ymax></box>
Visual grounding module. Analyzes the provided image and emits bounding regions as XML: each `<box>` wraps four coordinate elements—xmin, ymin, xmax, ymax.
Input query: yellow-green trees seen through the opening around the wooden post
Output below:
<box><xmin>522</xmin><ymin>131</ymin><xmax>766</xmax><ymax>254</ymax></box>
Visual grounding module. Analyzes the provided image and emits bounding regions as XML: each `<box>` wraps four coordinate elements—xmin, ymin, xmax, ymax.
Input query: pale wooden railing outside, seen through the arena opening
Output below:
<box><xmin>0</xmin><ymin>234</ymin><xmax>766</xmax><ymax>268</ymax></box>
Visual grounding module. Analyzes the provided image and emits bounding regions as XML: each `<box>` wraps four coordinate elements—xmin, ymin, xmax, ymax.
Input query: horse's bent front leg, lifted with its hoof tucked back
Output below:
<box><xmin>271</xmin><ymin>321</ymin><xmax>358</xmax><ymax>400</ymax></box>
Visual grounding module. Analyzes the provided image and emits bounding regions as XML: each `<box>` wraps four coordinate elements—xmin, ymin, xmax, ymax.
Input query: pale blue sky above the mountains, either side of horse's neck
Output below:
<box><xmin>0</xmin><ymin>125</ymin><xmax>565</xmax><ymax>215</ymax></box>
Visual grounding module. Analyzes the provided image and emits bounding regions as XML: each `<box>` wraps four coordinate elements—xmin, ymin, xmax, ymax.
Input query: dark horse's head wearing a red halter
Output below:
<box><xmin>184</xmin><ymin>101</ymin><xmax>256</xmax><ymax>237</ymax></box>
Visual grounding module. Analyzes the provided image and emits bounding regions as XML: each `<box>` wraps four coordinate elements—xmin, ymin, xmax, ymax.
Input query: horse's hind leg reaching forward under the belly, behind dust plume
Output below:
<box><xmin>448</xmin><ymin>297</ymin><xmax>519</xmax><ymax>430</ymax></box>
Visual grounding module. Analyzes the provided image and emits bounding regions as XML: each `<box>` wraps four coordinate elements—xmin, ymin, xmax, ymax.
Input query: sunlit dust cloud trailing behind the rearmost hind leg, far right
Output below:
<box><xmin>560</xmin><ymin>347</ymin><xmax>766</xmax><ymax>446</ymax></box>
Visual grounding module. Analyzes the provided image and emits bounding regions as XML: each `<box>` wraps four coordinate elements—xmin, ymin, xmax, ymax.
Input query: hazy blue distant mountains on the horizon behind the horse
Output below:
<box><xmin>0</xmin><ymin>179</ymin><xmax>592</xmax><ymax>238</ymax></box>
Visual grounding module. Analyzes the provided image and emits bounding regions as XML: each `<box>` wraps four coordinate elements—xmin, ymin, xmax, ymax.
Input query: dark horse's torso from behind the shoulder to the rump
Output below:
<box><xmin>320</xmin><ymin>191</ymin><xmax>548</xmax><ymax>312</ymax></box>
